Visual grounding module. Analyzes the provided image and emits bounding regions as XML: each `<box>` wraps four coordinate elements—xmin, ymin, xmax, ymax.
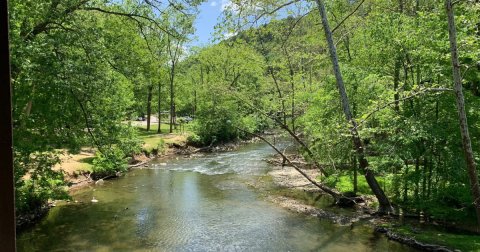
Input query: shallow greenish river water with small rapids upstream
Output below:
<box><xmin>17</xmin><ymin>143</ymin><xmax>415</xmax><ymax>252</ymax></box>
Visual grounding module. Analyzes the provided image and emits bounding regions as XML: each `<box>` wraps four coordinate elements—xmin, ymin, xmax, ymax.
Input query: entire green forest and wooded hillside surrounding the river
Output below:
<box><xmin>10</xmin><ymin>0</ymin><xmax>480</xmax><ymax>228</ymax></box>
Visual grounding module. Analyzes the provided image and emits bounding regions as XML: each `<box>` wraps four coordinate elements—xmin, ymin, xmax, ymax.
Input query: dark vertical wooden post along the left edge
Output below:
<box><xmin>0</xmin><ymin>0</ymin><xmax>17</xmax><ymax>249</ymax></box>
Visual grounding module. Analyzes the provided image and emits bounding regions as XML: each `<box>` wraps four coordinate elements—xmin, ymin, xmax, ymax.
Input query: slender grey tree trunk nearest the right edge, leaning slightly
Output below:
<box><xmin>445</xmin><ymin>0</ymin><xmax>480</xmax><ymax>225</ymax></box>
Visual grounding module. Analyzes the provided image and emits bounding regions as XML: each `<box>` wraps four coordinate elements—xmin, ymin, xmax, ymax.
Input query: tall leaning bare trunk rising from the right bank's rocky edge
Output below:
<box><xmin>316</xmin><ymin>0</ymin><xmax>392</xmax><ymax>213</ymax></box>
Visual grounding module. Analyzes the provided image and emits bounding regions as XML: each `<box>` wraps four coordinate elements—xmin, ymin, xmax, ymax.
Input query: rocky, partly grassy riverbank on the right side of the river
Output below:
<box><xmin>258</xmin><ymin>157</ymin><xmax>480</xmax><ymax>252</ymax></box>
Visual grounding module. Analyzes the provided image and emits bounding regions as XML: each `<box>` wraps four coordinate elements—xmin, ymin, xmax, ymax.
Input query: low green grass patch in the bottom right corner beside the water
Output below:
<box><xmin>382</xmin><ymin>225</ymin><xmax>480</xmax><ymax>252</ymax></box>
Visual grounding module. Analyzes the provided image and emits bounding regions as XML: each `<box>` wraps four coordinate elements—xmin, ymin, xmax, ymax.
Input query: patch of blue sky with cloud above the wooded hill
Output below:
<box><xmin>191</xmin><ymin>0</ymin><xmax>230</xmax><ymax>46</ymax></box>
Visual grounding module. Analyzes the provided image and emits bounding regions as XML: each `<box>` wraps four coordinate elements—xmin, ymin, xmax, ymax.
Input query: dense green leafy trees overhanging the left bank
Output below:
<box><xmin>9</xmin><ymin>0</ymin><xmax>199</xmax><ymax>210</ymax></box>
